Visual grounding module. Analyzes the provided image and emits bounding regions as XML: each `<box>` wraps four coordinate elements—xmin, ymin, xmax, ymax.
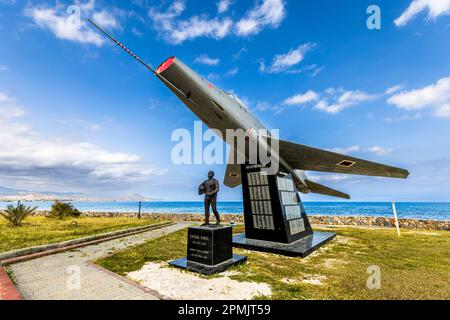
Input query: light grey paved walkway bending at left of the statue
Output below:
<box><xmin>9</xmin><ymin>222</ymin><xmax>191</xmax><ymax>300</ymax></box>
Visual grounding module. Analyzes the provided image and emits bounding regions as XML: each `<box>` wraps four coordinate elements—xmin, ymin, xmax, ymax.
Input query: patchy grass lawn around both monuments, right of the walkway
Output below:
<box><xmin>97</xmin><ymin>227</ymin><xmax>450</xmax><ymax>299</ymax></box>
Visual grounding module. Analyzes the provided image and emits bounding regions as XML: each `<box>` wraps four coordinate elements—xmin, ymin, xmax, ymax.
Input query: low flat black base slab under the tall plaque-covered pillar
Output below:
<box><xmin>233</xmin><ymin>231</ymin><xmax>336</xmax><ymax>258</ymax></box>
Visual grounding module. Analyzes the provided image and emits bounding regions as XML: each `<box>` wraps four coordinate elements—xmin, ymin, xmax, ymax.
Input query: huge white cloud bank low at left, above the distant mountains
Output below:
<box><xmin>0</xmin><ymin>93</ymin><xmax>164</xmax><ymax>187</ymax></box>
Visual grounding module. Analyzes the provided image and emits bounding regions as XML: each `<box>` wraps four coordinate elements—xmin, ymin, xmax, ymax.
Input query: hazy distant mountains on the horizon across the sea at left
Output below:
<box><xmin>0</xmin><ymin>187</ymin><xmax>156</xmax><ymax>202</ymax></box>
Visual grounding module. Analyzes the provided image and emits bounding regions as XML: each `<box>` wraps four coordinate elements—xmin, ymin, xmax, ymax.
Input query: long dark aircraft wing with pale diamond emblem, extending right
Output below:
<box><xmin>279</xmin><ymin>140</ymin><xmax>409</xmax><ymax>179</ymax></box>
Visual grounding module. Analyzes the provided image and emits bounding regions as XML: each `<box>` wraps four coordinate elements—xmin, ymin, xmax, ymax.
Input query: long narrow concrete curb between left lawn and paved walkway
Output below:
<box><xmin>0</xmin><ymin>222</ymin><xmax>175</xmax><ymax>266</ymax></box>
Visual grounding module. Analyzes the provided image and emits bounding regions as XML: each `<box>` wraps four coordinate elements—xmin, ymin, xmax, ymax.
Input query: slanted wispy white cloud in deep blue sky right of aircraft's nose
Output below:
<box><xmin>260</xmin><ymin>43</ymin><xmax>315</xmax><ymax>73</ymax></box>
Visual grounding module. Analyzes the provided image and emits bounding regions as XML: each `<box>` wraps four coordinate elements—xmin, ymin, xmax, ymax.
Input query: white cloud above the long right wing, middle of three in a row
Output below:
<box><xmin>315</xmin><ymin>88</ymin><xmax>376</xmax><ymax>114</ymax></box>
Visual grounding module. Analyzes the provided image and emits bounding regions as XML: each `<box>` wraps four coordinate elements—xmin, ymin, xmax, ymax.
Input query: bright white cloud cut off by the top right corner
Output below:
<box><xmin>394</xmin><ymin>0</ymin><xmax>450</xmax><ymax>27</ymax></box>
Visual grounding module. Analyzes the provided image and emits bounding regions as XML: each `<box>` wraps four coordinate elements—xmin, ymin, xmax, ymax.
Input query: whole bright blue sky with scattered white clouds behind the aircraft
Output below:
<box><xmin>0</xmin><ymin>0</ymin><xmax>450</xmax><ymax>201</ymax></box>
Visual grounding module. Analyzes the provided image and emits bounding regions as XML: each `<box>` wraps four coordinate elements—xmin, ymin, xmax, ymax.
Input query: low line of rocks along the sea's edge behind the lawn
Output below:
<box><xmin>33</xmin><ymin>211</ymin><xmax>450</xmax><ymax>231</ymax></box>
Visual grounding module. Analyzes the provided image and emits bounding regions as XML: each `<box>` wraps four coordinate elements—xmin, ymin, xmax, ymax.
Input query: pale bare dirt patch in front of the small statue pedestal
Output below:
<box><xmin>127</xmin><ymin>263</ymin><xmax>272</xmax><ymax>300</ymax></box>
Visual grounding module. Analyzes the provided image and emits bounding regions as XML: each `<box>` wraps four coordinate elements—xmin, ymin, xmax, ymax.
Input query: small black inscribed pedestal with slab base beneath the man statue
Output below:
<box><xmin>169</xmin><ymin>226</ymin><xmax>247</xmax><ymax>275</ymax></box>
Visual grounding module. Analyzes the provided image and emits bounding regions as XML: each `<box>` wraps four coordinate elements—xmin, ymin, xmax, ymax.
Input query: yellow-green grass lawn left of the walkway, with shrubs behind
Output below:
<box><xmin>0</xmin><ymin>217</ymin><xmax>163</xmax><ymax>252</ymax></box>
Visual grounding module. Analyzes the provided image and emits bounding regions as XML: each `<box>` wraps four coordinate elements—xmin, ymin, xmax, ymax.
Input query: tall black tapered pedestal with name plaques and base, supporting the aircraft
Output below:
<box><xmin>233</xmin><ymin>165</ymin><xmax>335</xmax><ymax>257</ymax></box>
